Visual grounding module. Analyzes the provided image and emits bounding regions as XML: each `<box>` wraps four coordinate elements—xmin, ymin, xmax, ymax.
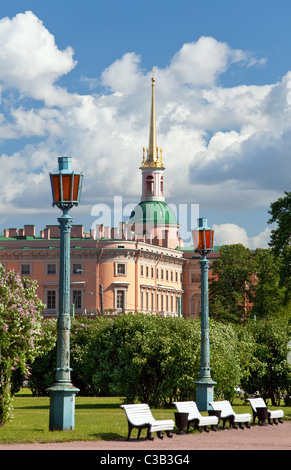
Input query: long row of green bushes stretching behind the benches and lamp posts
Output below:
<box><xmin>24</xmin><ymin>314</ymin><xmax>290</xmax><ymax>408</ymax></box>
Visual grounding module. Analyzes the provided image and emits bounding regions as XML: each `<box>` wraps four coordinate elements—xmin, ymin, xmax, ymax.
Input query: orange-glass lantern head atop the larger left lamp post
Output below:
<box><xmin>50</xmin><ymin>157</ymin><xmax>83</xmax><ymax>210</ymax></box>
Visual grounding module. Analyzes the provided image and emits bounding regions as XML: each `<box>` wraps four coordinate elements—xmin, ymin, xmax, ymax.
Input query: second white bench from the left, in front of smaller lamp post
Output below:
<box><xmin>174</xmin><ymin>401</ymin><xmax>219</xmax><ymax>432</ymax></box>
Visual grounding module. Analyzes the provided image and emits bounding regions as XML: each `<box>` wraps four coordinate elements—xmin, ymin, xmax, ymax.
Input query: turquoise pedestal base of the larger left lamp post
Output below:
<box><xmin>47</xmin><ymin>384</ymin><xmax>79</xmax><ymax>431</ymax></box>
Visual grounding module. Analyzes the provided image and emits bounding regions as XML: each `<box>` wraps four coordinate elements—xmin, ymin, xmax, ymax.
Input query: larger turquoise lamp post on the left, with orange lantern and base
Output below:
<box><xmin>47</xmin><ymin>157</ymin><xmax>83</xmax><ymax>431</ymax></box>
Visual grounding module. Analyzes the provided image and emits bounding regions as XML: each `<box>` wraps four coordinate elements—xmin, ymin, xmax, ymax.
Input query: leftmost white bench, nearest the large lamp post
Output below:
<box><xmin>121</xmin><ymin>403</ymin><xmax>175</xmax><ymax>441</ymax></box>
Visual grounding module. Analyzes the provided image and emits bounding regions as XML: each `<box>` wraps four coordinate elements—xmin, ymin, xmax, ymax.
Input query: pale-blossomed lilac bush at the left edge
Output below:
<box><xmin>0</xmin><ymin>265</ymin><xmax>44</xmax><ymax>425</ymax></box>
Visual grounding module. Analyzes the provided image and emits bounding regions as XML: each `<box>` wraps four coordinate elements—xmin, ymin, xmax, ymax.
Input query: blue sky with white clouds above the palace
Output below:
<box><xmin>0</xmin><ymin>0</ymin><xmax>291</xmax><ymax>249</ymax></box>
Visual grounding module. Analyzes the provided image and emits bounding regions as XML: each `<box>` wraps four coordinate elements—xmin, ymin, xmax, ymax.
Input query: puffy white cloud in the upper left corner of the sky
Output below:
<box><xmin>0</xmin><ymin>11</ymin><xmax>76</xmax><ymax>106</ymax></box>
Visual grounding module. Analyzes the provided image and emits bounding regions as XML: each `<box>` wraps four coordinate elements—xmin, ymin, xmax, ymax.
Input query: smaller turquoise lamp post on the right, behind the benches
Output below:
<box><xmin>192</xmin><ymin>218</ymin><xmax>216</xmax><ymax>411</ymax></box>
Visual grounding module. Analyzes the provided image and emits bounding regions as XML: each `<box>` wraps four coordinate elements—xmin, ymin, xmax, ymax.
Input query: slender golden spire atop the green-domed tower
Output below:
<box><xmin>141</xmin><ymin>67</ymin><xmax>164</xmax><ymax>168</ymax></box>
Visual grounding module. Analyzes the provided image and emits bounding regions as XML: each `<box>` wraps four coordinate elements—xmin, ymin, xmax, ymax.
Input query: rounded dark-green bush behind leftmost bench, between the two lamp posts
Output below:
<box><xmin>85</xmin><ymin>314</ymin><xmax>200</xmax><ymax>407</ymax></box>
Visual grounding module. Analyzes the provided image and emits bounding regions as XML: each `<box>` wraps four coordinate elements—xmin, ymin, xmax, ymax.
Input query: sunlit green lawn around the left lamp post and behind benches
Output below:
<box><xmin>0</xmin><ymin>389</ymin><xmax>291</xmax><ymax>444</ymax></box>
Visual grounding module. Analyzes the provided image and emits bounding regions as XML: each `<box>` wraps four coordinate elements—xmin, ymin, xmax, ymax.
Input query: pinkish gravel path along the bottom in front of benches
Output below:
<box><xmin>0</xmin><ymin>421</ymin><xmax>291</xmax><ymax>452</ymax></box>
